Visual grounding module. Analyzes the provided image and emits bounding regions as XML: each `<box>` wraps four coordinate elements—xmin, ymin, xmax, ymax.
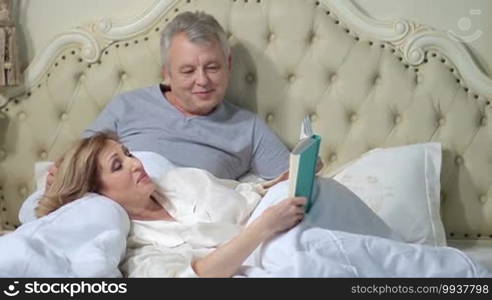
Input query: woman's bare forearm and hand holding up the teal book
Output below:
<box><xmin>193</xmin><ymin>197</ymin><xmax>306</xmax><ymax>277</ymax></box>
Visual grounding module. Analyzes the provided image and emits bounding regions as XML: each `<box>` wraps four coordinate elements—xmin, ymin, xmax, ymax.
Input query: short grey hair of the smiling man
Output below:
<box><xmin>161</xmin><ymin>11</ymin><xmax>230</xmax><ymax>66</ymax></box>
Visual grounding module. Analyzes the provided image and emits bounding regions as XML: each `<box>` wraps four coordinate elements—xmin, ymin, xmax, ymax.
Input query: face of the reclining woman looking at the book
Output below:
<box><xmin>98</xmin><ymin>140</ymin><xmax>155</xmax><ymax>210</ymax></box>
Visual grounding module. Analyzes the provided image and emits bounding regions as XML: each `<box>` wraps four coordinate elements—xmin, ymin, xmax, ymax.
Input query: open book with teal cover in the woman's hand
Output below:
<box><xmin>288</xmin><ymin>117</ymin><xmax>321</xmax><ymax>212</ymax></box>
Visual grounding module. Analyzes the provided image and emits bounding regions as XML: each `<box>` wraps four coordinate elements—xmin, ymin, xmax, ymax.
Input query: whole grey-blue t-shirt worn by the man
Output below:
<box><xmin>83</xmin><ymin>85</ymin><xmax>289</xmax><ymax>179</ymax></box>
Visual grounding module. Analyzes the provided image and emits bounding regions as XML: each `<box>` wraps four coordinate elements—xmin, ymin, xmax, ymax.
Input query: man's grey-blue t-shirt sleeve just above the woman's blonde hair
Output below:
<box><xmin>82</xmin><ymin>96</ymin><xmax>123</xmax><ymax>138</ymax></box>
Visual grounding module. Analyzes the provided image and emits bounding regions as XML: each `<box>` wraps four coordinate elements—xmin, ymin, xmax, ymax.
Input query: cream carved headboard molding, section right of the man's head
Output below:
<box><xmin>322</xmin><ymin>0</ymin><xmax>492</xmax><ymax>98</ymax></box>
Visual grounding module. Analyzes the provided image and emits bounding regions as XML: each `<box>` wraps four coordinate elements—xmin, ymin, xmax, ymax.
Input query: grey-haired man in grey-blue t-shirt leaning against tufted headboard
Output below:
<box><xmin>83</xmin><ymin>12</ymin><xmax>289</xmax><ymax>179</ymax></box>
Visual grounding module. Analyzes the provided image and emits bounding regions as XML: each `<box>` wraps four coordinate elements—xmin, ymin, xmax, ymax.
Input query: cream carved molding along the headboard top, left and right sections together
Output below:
<box><xmin>9</xmin><ymin>0</ymin><xmax>492</xmax><ymax>98</ymax></box>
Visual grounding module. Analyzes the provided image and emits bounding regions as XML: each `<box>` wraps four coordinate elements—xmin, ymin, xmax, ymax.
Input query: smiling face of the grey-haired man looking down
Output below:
<box><xmin>163</xmin><ymin>33</ymin><xmax>230</xmax><ymax>115</ymax></box>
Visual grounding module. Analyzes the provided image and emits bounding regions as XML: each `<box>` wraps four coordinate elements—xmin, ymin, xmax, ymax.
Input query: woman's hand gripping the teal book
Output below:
<box><xmin>255</xmin><ymin>197</ymin><xmax>306</xmax><ymax>238</ymax></box>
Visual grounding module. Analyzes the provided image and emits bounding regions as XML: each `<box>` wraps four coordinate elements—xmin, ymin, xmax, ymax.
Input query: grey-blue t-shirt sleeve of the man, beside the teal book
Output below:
<box><xmin>251</xmin><ymin>116</ymin><xmax>289</xmax><ymax>179</ymax></box>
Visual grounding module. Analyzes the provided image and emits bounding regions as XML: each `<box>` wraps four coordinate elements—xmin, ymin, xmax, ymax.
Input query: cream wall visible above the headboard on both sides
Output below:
<box><xmin>15</xmin><ymin>0</ymin><xmax>492</xmax><ymax>74</ymax></box>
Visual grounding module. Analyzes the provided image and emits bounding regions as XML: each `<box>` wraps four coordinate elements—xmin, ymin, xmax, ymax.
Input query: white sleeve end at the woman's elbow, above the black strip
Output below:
<box><xmin>121</xmin><ymin>245</ymin><xmax>198</xmax><ymax>278</ymax></box>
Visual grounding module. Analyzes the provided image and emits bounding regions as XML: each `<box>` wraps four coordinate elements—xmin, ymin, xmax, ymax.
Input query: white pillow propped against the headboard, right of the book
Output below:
<box><xmin>333</xmin><ymin>143</ymin><xmax>446</xmax><ymax>246</ymax></box>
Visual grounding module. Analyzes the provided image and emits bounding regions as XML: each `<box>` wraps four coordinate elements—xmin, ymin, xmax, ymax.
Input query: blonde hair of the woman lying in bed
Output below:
<box><xmin>36</xmin><ymin>132</ymin><xmax>119</xmax><ymax>218</ymax></box>
